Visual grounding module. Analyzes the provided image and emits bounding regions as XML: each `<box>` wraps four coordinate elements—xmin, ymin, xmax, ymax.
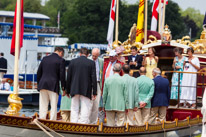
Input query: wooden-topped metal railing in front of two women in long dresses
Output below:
<box><xmin>162</xmin><ymin>71</ymin><xmax>206</xmax><ymax>109</ymax></box>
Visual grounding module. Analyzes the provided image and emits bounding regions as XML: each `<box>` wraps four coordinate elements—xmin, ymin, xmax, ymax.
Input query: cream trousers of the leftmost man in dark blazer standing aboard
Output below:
<box><xmin>39</xmin><ymin>89</ymin><xmax>59</xmax><ymax>120</ymax></box>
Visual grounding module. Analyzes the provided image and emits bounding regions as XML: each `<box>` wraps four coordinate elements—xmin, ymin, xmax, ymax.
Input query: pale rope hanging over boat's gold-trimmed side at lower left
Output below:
<box><xmin>34</xmin><ymin>119</ymin><xmax>64</xmax><ymax>137</ymax></box>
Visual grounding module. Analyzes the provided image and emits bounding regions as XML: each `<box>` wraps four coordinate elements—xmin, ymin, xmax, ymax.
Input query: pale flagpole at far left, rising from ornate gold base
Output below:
<box><xmin>13</xmin><ymin>0</ymin><xmax>21</xmax><ymax>94</ymax></box>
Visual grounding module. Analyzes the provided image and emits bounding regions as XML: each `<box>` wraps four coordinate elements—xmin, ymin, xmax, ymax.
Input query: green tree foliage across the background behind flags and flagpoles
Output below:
<box><xmin>0</xmin><ymin>0</ymin><xmax>204</xmax><ymax>44</ymax></box>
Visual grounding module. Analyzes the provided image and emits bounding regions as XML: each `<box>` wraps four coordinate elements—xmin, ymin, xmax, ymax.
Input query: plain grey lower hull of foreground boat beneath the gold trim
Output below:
<box><xmin>0</xmin><ymin>125</ymin><xmax>202</xmax><ymax>137</ymax></box>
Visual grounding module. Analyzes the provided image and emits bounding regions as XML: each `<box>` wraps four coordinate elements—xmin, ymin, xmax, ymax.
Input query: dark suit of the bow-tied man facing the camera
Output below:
<box><xmin>128</xmin><ymin>55</ymin><xmax>143</xmax><ymax>77</ymax></box>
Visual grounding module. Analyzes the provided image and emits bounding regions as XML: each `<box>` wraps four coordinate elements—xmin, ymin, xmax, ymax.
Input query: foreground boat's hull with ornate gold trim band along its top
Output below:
<box><xmin>0</xmin><ymin>112</ymin><xmax>202</xmax><ymax>137</ymax></box>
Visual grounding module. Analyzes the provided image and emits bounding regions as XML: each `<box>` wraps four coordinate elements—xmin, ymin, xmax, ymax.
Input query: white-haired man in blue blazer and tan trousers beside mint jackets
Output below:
<box><xmin>150</xmin><ymin>68</ymin><xmax>170</xmax><ymax>124</ymax></box>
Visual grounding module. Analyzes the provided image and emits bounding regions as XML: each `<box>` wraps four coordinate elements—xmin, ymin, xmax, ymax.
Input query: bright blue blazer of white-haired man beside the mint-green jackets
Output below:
<box><xmin>152</xmin><ymin>76</ymin><xmax>170</xmax><ymax>107</ymax></box>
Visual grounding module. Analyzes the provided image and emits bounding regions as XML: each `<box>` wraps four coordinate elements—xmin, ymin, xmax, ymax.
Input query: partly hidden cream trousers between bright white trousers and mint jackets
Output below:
<box><xmin>89</xmin><ymin>83</ymin><xmax>101</xmax><ymax>124</ymax></box>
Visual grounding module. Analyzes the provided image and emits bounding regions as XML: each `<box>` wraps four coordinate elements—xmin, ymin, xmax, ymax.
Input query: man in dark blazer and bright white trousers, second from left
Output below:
<box><xmin>66</xmin><ymin>48</ymin><xmax>97</xmax><ymax>124</ymax></box>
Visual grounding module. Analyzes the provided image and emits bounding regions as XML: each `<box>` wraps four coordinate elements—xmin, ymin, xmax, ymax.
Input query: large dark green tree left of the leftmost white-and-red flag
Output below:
<box><xmin>63</xmin><ymin>0</ymin><xmax>110</xmax><ymax>43</ymax></box>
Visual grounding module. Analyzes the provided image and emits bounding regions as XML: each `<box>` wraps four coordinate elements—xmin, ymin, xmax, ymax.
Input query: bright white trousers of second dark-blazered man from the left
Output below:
<box><xmin>70</xmin><ymin>95</ymin><xmax>91</xmax><ymax>124</ymax></box>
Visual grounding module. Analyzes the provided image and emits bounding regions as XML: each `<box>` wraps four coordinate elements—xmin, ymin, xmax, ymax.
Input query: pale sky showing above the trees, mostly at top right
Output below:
<box><xmin>125</xmin><ymin>0</ymin><xmax>206</xmax><ymax>14</ymax></box>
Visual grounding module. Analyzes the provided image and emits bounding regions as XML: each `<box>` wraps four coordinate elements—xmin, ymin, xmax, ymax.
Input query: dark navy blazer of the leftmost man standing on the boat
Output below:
<box><xmin>37</xmin><ymin>53</ymin><xmax>65</xmax><ymax>93</ymax></box>
